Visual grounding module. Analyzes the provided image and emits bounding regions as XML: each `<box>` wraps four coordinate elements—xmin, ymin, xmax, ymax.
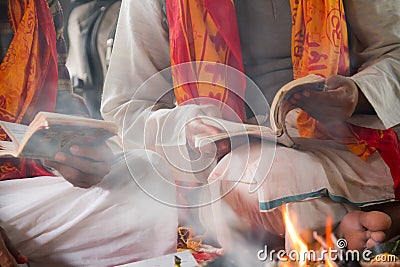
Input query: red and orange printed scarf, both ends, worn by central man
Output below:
<box><xmin>166</xmin><ymin>0</ymin><xmax>400</xmax><ymax>199</ymax></box>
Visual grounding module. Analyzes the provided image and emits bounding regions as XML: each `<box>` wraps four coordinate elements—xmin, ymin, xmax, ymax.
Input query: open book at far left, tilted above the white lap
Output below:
<box><xmin>0</xmin><ymin>112</ymin><xmax>118</xmax><ymax>159</ymax></box>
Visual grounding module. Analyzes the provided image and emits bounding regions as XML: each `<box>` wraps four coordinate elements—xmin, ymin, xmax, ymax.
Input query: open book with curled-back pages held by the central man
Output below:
<box><xmin>195</xmin><ymin>74</ymin><xmax>327</xmax><ymax>147</ymax></box>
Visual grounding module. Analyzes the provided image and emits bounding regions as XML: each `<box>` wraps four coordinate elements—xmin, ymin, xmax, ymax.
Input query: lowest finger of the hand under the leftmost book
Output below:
<box><xmin>46</xmin><ymin>161</ymin><xmax>104</xmax><ymax>188</ymax></box>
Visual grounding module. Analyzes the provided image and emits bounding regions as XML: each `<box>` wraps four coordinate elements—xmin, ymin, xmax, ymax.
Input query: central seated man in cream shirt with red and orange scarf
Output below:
<box><xmin>102</xmin><ymin>0</ymin><xmax>400</xmax><ymax>255</ymax></box>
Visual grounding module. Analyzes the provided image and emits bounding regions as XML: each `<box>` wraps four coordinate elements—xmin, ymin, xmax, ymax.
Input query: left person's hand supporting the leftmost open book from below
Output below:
<box><xmin>45</xmin><ymin>143</ymin><xmax>113</xmax><ymax>188</ymax></box>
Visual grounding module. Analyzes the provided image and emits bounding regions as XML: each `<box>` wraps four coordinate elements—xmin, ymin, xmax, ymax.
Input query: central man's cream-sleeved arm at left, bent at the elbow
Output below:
<box><xmin>102</xmin><ymin>0</ymin><xmax>219</xmax><ymax>182</ymax></box>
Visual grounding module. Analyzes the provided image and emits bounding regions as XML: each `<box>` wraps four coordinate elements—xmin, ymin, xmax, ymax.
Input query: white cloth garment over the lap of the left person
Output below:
<box><xmin>0</xmin><ymin>150</ymin><xmax>177</xmax><ymax>266</ymax></box>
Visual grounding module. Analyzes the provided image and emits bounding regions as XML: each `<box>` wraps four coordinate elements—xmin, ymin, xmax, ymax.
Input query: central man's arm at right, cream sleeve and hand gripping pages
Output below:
<box><xmin>291</xmin><ymin>0</ymin><xmax>400</xmax><ymax>129</ymax></box>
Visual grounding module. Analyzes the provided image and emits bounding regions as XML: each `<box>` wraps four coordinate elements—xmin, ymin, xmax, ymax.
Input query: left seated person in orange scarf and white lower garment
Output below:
<box><xmin>0</xmin><ymin>0</ymin><xmax>177</xmax><ymax>266</ymax></box>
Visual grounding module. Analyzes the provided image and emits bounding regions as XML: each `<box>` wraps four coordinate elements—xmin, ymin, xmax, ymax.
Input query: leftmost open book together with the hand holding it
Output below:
<box><xmin>0</xmin><ymin>112</ymin><xmax>118</xmax><ymax>188</ymax></box>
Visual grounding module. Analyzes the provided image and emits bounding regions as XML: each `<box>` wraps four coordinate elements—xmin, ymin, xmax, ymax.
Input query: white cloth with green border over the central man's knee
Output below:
<box><xmin>200</xmin><ymin>111</ymin><xmax>394</xmax><ymax>249</ymax></box>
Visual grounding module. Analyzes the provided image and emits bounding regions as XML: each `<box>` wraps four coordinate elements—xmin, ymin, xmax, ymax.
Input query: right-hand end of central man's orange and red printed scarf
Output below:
<box><xmin>290</xmin><ymin>0</ymin><xmax>400</xmax><ymax>199</ymax></box>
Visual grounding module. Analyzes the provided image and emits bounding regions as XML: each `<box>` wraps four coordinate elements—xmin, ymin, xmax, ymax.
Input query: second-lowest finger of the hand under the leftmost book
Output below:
<box><xmin>54</xmin><ymin>152</ymin><xmax>111</xmax><ymax>176</ymax></box>
